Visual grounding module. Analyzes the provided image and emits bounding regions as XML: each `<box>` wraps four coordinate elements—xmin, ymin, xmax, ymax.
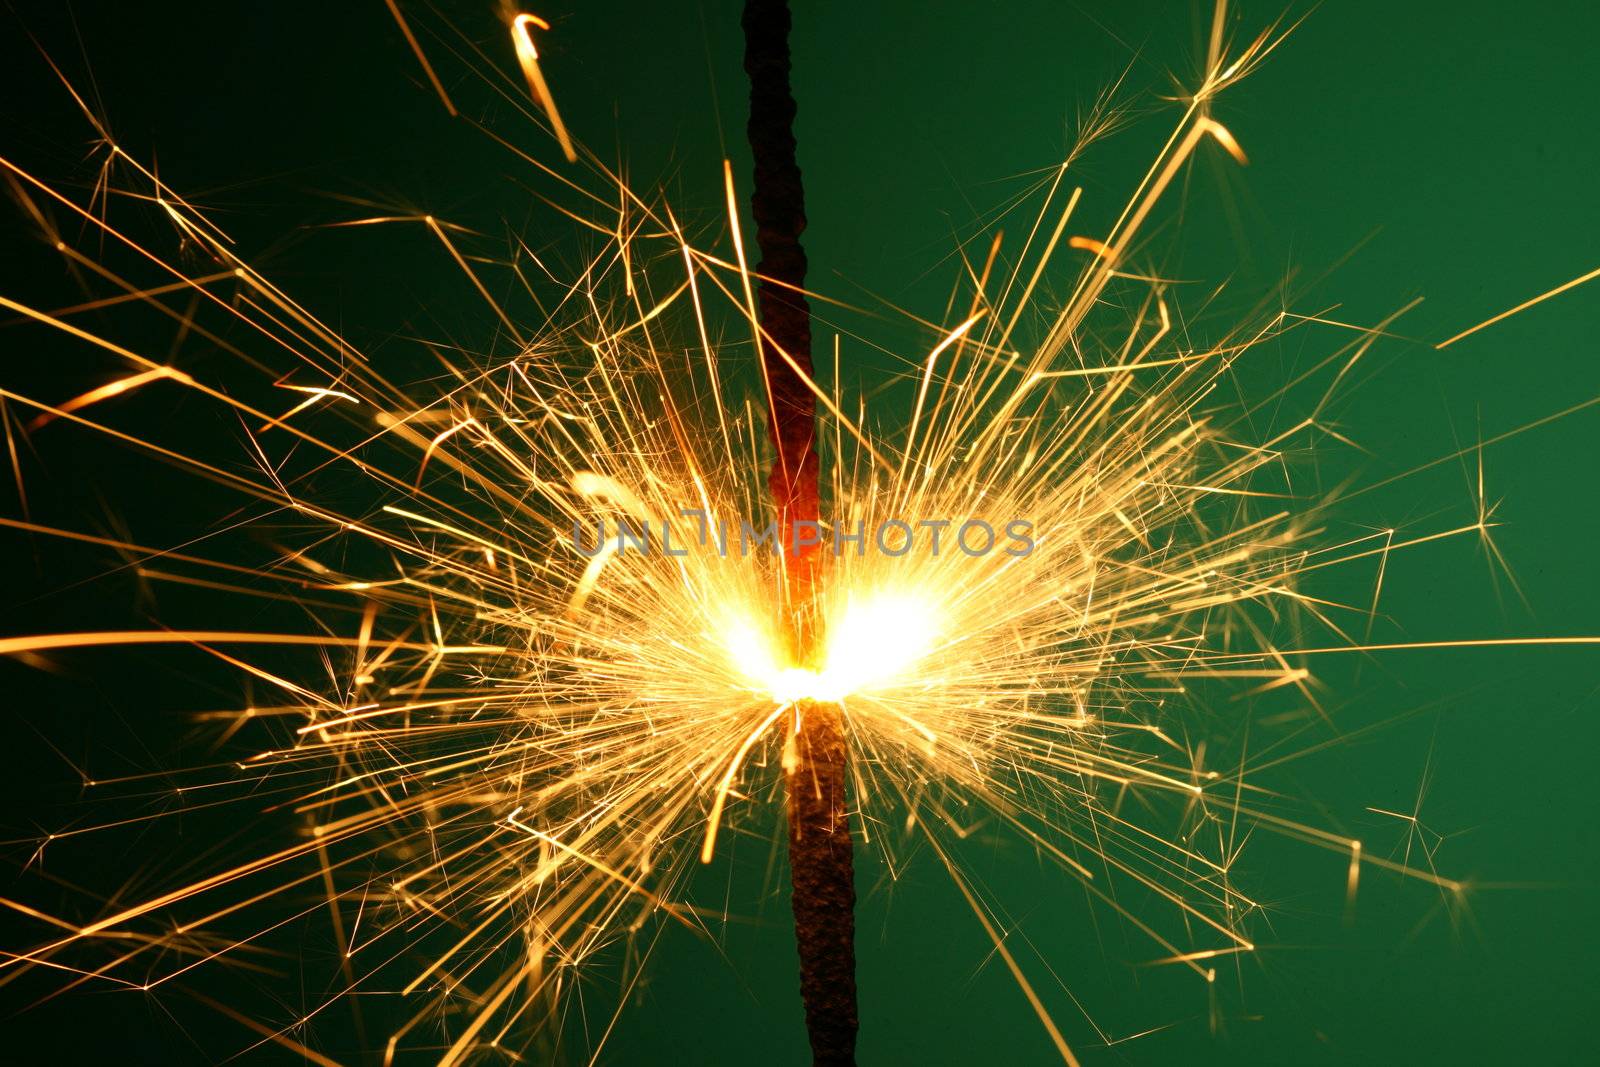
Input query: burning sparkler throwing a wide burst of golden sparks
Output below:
<box><xmin>0</xmin><ymin>5</ymin><xmax>1600</xmax><ymax>1064</ymax></box>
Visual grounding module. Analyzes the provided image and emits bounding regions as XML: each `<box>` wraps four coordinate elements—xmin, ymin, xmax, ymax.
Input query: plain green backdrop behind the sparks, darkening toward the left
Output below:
<box><xmin>0</xmin><ymin>0</ymin><xmax>1600</xmax><ymax>1064</ymax></box>
